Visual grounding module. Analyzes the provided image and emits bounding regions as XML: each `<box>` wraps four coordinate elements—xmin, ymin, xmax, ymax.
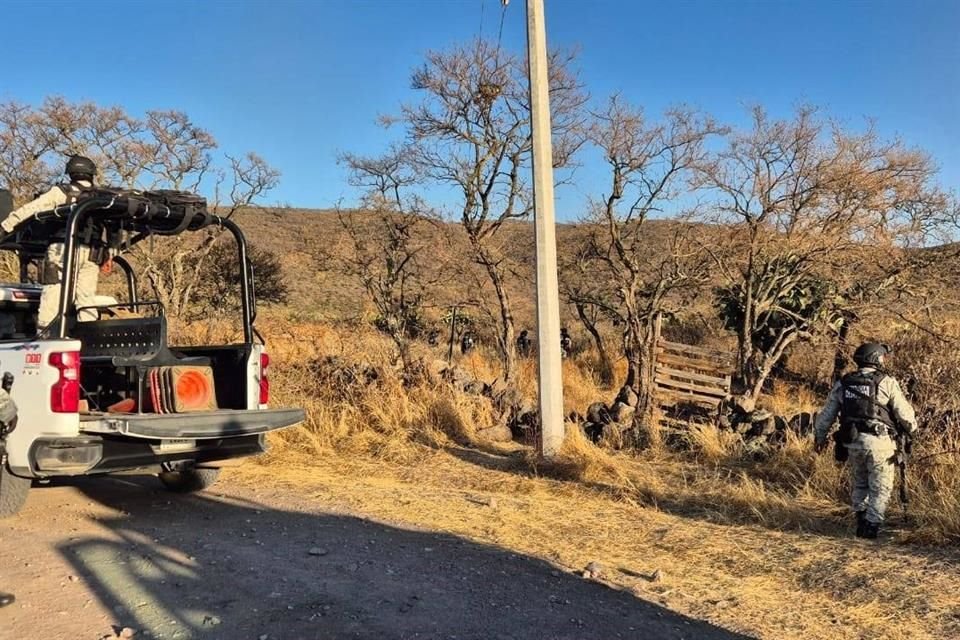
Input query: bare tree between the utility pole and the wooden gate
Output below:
<box><xmin>581</xmin><ymin>96</ymin><xmax>721</xmax><ymax>435</ymax></box>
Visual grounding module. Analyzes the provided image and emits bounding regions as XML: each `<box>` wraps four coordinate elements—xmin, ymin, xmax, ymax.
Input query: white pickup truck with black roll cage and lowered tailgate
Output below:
<box><xmin>0</xmin><ymin>192</ymin><xmax>304</xmax><ymax>517</ymax></box>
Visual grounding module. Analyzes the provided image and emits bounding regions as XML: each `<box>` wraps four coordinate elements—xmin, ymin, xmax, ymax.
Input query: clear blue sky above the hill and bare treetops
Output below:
<box><xmin>0</xmin><ymin>0</ymin><xmax>960</xmax><ymax>219</ymax></box>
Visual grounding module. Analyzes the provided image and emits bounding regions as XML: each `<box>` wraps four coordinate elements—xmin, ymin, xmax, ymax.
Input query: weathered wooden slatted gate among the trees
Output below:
<box><xmin>653</xmin><ymin>322</ymin><xmax>734</xmax><ymax>422</ymax></box>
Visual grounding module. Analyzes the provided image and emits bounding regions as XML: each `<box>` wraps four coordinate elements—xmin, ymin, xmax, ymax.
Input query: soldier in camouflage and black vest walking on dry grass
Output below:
<box><xmin>815</xmin><ymin>342</ymin><xmax>917</xmax><ymax>538</ymax></box>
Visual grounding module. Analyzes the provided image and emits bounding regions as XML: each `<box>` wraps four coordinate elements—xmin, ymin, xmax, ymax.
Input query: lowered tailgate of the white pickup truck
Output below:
<box><xmin>80</xmin><ymin>409</ymin><xmax>306</xmax><ymax>440</ymax></box>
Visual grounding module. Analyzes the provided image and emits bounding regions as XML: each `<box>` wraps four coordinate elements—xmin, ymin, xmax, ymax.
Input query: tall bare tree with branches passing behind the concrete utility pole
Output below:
<box><xmin>385</xmin><ymin>41</ymin><xmax>585</xmax><ymax>381</ymax></box>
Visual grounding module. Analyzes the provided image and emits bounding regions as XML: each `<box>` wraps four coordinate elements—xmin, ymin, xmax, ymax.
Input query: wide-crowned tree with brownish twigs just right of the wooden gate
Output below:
<box><xmin>700</xmin><ymin>107</ymin><xmax>943</xmax><ymax>410</ymax></box>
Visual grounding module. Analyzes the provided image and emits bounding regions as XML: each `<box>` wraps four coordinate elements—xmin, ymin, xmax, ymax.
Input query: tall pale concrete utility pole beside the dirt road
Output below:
<box><xmin>527</xmin><ymin>0</ymin><xmax>564</xmax><ymax>458</ymax></box>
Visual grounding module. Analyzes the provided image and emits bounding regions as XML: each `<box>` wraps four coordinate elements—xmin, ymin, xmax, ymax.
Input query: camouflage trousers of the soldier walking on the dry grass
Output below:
<box><xmin>847</xmin><ymin>433</ymin><xmax>897</xmax><ymax>523</ymax></box>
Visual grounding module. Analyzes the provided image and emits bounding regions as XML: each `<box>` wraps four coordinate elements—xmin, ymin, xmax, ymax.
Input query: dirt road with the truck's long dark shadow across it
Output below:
<box><xmin>0</xmin><ymin>476</ymin><xmax>745</xmax><ymax>640</ymax></box>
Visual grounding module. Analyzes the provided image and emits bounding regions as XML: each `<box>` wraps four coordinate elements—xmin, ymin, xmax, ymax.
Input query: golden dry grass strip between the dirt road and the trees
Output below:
<box><xmin>172</xmin><ymin>318</ymin><xmax>960</xmax><ymax>638</ymax></box>
